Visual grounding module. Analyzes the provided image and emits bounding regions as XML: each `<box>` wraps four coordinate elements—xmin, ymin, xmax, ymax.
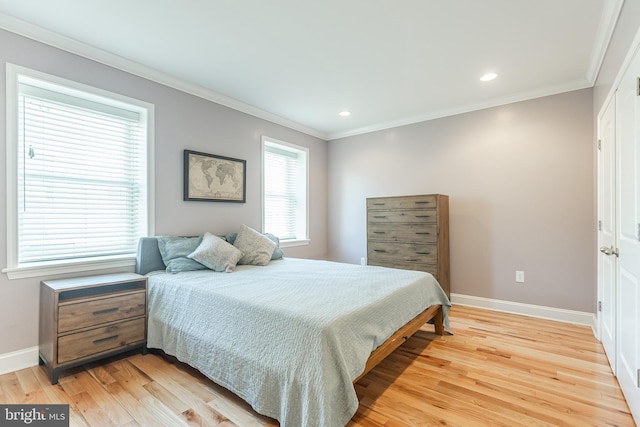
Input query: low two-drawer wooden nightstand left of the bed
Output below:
<box><xmin>39</xmin><ymin>273</ymin><xmax>147</xmax><ymax>384</ymax></box>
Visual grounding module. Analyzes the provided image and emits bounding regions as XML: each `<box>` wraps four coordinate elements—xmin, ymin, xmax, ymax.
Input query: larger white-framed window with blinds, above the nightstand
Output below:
<box><xmin>4</xmin><ymin>64</ymin><xmax>153</xmax><ymax>278</ymax></box>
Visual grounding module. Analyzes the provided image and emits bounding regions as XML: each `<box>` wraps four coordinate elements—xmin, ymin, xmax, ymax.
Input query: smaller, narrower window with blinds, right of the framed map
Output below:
<box><xmin>262</xmin><ymin>137</ymin><xmax>309</xmax><ymax>246</ymax></box>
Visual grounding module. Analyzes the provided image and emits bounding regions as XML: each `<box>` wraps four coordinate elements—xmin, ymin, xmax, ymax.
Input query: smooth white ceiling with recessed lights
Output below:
<box><xmin>0</xmin><ymin>0</ymin><xmax>623</xmax><ymax>139</ymax></box>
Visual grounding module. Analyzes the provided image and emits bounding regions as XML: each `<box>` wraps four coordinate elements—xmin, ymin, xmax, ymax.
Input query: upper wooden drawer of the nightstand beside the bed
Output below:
<box><xmin>58</xmin><ymin>291</ymin><xmax>147</xmax><ymax>333</ymax></box>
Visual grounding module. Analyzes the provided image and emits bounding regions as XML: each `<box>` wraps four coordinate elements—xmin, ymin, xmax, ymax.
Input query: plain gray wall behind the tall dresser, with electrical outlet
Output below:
<box><xmin>328</xmin><ymin>89</ymin><xmax>596</xmax><ymax>312</ymax></box>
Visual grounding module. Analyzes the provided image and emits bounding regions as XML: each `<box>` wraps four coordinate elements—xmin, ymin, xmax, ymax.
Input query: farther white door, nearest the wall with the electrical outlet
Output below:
<box><xmin>598</xmin><ymin>95</ymin><xmax>617</xmax><ymax>374</ymax></box>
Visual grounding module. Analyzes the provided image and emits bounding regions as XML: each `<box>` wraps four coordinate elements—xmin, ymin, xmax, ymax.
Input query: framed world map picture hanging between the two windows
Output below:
<box><xmin>184</xmin><ymin>150</ymin><xmax>247</xmax><ymax>203</ymax></box>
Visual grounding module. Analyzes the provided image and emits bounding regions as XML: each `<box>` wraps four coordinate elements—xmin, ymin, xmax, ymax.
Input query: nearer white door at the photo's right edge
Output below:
<box><xmin>616</xmin><ymin>46</ymin><xmax>640</xmax><ymax>420</ymax></box>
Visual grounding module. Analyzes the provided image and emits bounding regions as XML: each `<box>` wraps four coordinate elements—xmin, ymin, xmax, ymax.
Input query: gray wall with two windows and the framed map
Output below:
<box><xmin>0</xmin><ymin>30</ymin><xmax>327</xmax><ymax>355</ymax></box>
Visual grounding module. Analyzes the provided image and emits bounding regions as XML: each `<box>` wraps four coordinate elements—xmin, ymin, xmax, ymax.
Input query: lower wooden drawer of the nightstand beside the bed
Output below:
<box><xmin>58</xmin><ymin>318</ymin><xmax>145</xmax><ymax>363</ymax></box>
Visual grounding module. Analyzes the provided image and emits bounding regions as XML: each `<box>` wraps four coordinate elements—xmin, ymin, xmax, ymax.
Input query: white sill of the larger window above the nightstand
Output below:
<box><xmin>2</xmin><ymin>256</ymin><xmax>136</xmax><ymax>280</ymax></box>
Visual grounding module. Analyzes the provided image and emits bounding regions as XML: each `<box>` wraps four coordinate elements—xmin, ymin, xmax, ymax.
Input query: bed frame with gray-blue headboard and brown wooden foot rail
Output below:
<box><xmin>135</xmin><ymin>237</ymin><xmax>444</xmax><ymax>384</ymax></box>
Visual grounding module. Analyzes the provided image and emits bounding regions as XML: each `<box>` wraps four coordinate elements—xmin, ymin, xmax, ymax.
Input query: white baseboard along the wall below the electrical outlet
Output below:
<box><xmin>451</xmin><ymin>293</ymin><xmax>598</xmax><ymax>337</ymax></box>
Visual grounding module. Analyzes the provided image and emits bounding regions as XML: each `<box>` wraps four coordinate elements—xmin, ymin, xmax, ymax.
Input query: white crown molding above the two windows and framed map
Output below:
<box><xmin>0</xmin><ymin>13</ymin><xmax>327</xmax><ymax>140</ymax></box>
